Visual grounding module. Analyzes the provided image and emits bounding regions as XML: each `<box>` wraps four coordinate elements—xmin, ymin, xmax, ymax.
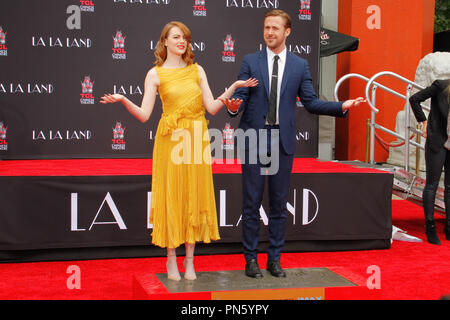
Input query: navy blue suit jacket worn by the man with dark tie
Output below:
<box><xmin>230</xmin><ymin>48</ymin><xmax>345</xmax><ymax>154</ymax></box>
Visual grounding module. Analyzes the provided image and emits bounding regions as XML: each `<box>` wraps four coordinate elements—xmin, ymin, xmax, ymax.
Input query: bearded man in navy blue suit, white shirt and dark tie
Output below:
<box><xmin>222</xmin><ymin>9</ymin><xmax>364</xmax><ymax>278</ymax></box>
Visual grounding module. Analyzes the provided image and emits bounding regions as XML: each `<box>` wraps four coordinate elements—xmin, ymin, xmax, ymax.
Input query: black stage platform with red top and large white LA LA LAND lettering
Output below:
<box><xmin>0</xmin><ymin>159</ymin><xmax>393</xmax><ymax>262</ymax></box>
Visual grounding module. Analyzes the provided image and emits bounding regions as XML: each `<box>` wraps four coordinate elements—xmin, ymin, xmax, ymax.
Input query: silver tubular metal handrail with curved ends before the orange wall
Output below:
<box><xmin>334</xmin><ymin>71</ymin><xmax>430</xmax><ymax>170</ymax></box>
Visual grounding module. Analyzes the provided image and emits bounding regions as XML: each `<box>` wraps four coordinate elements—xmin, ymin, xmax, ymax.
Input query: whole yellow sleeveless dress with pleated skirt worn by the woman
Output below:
<box><xmin>150</xmin><ymin>64</ymin><xmax>220</xmax><ymax>248</ymax></box>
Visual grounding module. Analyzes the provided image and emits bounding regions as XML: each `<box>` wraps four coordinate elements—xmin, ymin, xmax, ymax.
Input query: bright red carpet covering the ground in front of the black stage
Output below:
<box><xmin>0</xmin><ymin>200</ymin><xmax>450</xmax><ymax>300</ymax></box>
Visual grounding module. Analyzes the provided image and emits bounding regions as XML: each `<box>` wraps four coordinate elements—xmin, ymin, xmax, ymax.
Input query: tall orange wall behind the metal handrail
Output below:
<box><xmin>336</xmin><ymin>0</ymin><xmax>435</xmax><ymax>162</ymax></box>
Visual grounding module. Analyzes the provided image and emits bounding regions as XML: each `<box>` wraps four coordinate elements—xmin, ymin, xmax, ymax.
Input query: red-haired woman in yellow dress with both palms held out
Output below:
<box><xmin>100</xmin><ymin>21</ymin><xmax>258</xmax><ymax>281</ymax></box>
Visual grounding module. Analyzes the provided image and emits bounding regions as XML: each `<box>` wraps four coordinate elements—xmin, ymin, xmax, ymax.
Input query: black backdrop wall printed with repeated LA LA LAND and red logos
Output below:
<box><xmin>0</xmin><ymin>0</ymin><xmax>321</xmax><ymax>159</ymax></box>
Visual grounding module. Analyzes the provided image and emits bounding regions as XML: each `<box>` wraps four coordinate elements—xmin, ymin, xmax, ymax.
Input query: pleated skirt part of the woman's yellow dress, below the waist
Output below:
<box><xmin>150</xmin><ymin>115</ymin><xmax>220</xmax><ymax>248</ymax></box>
